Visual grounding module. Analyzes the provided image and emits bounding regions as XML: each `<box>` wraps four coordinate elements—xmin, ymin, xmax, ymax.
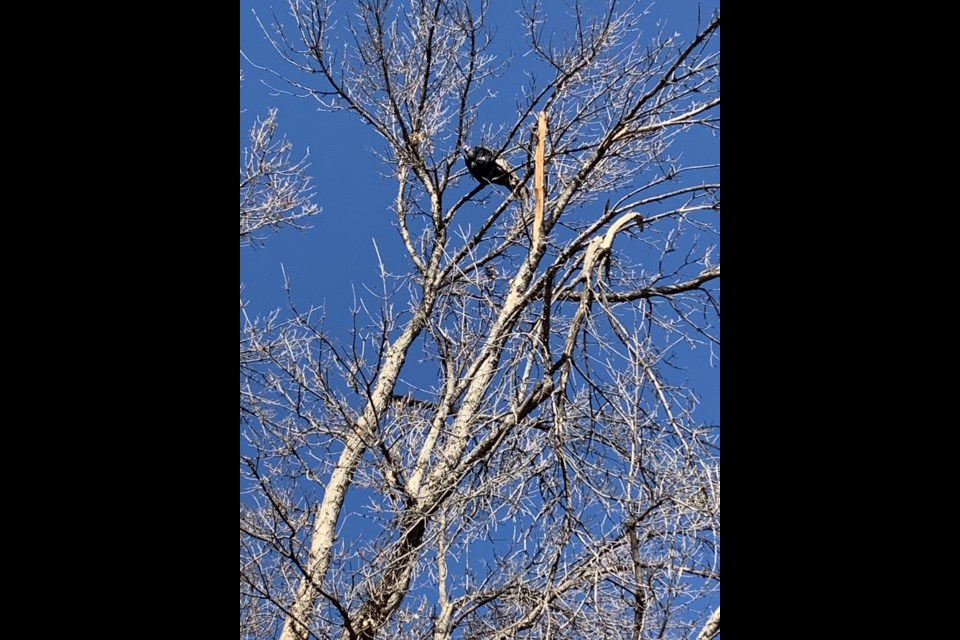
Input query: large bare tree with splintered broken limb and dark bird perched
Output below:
<box><xmin>240</xmin><ymin>0</ymin><xmax>720</xmax><ymax>640</ymax></box>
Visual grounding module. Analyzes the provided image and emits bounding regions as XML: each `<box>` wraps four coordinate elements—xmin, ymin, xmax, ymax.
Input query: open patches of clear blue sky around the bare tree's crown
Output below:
<box><xmin>240</xmin><ymin>0</ymin><xmax>719</xmax><ymax>421</ymax></box>
